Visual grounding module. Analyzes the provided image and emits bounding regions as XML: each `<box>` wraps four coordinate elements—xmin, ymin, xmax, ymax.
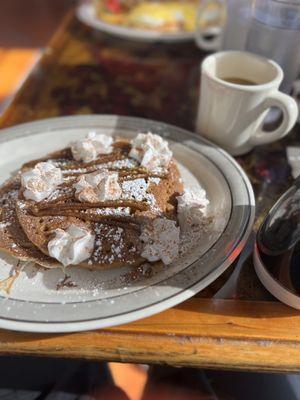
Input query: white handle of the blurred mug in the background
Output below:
<box><xmin>195</xmin><ymin>0</ymin><xmax>225</xmax><ymax>51</ymax></box>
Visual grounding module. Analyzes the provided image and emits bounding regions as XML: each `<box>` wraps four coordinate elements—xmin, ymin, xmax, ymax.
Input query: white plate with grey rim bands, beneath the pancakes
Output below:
<box><xmin>0</xmin><ymin>115</ymin><xmax>255</xmax><ymax>332</ymax></box>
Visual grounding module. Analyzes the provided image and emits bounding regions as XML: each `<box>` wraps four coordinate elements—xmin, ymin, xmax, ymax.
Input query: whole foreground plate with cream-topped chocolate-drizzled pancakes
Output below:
<box><xmin>0</xmin><ymin>115</ymin><xmax>255</xmax><ymax>332</ymax></box>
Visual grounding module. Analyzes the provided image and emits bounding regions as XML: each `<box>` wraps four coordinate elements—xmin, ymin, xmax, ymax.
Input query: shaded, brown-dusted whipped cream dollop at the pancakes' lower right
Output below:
<box><xmin>140</xmin><ymin>218</ymin><xmax>180</xmax><ymax>265</ymax></box>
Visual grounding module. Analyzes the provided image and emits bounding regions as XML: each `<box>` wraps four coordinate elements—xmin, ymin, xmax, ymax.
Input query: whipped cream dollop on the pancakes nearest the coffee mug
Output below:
<box><xmin>129</xmin><ymin>132</ymin><xmax>172</xmax><ymax>171</ymax></box>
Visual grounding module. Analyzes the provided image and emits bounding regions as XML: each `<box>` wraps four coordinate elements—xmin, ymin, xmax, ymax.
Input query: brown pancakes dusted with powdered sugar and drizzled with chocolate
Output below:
<box><xmin>0</xmin><ymin>139</ymin><xmax>183</xmax><ymax>269</ymax></box>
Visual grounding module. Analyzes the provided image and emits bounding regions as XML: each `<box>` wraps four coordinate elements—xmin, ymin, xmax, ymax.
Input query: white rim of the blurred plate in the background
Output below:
<box><xmin>76</xmin><ymin>1</ymin><xmax>195</xmax><ymax>42</ymax></box>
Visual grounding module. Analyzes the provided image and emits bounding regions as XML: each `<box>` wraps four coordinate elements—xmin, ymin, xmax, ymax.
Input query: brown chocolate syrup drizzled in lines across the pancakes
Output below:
<box><xmin>25</xmin><ymin>141</ymin><xmax>167</xmax><ymax>228</ymax></box>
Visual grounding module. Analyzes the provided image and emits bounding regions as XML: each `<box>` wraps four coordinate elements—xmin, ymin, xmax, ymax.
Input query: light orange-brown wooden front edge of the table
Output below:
<box><xmin>0</xmin><ymin>299</ymin><xmax>300</xmax><ymax>372</ymax></box>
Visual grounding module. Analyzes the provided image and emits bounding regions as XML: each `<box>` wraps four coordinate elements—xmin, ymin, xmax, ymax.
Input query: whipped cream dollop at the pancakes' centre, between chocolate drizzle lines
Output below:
<box><xmin>74</xmin><ymin>170</ymin><xmax>122</xmax><ymax>203</ymax></box>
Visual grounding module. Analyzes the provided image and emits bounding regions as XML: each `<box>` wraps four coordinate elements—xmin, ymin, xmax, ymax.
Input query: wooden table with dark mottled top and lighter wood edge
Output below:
<box><xmin>0</xmin><ymin>10</ymin><xmax>300</xmax><ymax>372</ymax></box>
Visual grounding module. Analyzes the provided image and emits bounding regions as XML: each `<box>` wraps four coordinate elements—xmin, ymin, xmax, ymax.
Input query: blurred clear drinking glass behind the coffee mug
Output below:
<box><xmin>246</xmin><ymin>0</ymin><xmax>300</xmax><ymax>93</ymax></box>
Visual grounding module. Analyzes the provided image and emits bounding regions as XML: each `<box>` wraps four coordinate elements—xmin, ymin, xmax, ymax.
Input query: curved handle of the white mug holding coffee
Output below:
<box><xmin>250</xmin><ymin>91</ymin><xmax>298</xmax><ymax>146</ymax></box>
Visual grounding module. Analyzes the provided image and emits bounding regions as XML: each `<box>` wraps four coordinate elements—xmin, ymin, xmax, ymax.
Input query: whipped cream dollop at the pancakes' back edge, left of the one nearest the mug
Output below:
<box><xmin>71</xmin><ymin>132</ymin><xmax>113</xmax><ymax>162</ymax></box>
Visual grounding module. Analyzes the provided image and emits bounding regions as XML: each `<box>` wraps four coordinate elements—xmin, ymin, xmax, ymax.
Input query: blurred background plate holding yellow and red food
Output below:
<box><xmin>77</xmin><ymin>0</ymin><xmax>198</xmax><ymax>42</ymax></box>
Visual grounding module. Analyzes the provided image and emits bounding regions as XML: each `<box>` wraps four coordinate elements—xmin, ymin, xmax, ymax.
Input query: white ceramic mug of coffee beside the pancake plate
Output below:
<box><xmin>196</xmin><ymin>51</ymin><xmax>298</xmax><ymax>155</ymax></box>
